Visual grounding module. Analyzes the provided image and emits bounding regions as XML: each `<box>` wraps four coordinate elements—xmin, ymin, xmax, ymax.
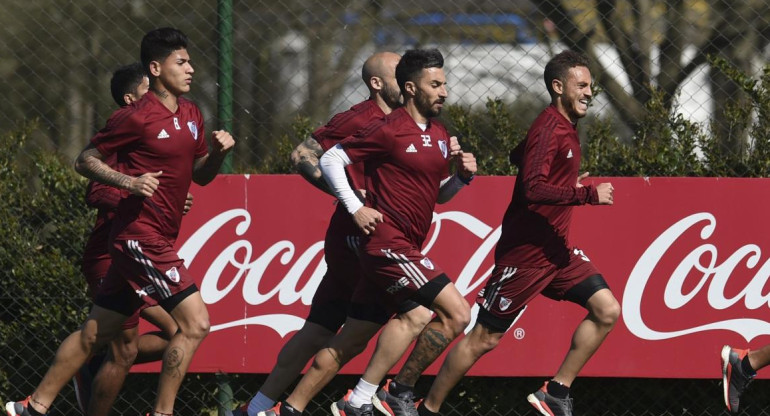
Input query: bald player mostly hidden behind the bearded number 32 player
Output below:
<box><xmin>233</xmin><ymin>52</ymin><xmax>431</xmax><ymax>416</ymax></box>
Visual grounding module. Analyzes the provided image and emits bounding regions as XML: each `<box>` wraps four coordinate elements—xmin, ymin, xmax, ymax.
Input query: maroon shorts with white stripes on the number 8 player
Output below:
<box><xmin>95</xmin><ymin>238</ymin><xmax>197</xmax><ymax>319</ymax></box>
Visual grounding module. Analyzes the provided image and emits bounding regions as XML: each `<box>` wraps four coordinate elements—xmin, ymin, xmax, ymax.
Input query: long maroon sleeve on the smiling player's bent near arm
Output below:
<box><xmin>519</xmin><ymin>122</ymin><xmax>593</xmax><ymax>205</ymax></box>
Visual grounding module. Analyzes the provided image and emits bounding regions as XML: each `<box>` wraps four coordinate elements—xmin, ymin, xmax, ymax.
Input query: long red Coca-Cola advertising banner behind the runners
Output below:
<box><xmin>139</xmin><ymin>175</ymin><xmax>770</xmax><ymax>378</ymax></box>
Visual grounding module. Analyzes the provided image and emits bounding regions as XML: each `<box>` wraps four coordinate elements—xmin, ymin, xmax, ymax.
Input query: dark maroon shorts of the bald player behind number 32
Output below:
<box><xmin>307</xmin><ymin>210</ymin><xmax>363</xmax><ymax>332</ymax></box>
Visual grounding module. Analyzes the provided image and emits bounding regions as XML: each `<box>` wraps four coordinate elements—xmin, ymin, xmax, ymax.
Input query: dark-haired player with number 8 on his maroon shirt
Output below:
<box><xmin>6</xmin><ymin>28</ymin><xmax>235</xmax><ymax>416</ymax></box>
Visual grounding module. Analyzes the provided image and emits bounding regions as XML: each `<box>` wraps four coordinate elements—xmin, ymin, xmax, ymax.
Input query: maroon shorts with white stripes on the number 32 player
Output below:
<box><xmin>353</xmin><ymin>248</ymin><xmax>450</xmax><ymax>314</ymax></box>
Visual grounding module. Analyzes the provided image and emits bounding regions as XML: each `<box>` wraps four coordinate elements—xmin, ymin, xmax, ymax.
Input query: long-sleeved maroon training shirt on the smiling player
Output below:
<box><xmin>495</xmin><ymin>105</ymin><xmax>599</xmax><ymax>267</ymax></box>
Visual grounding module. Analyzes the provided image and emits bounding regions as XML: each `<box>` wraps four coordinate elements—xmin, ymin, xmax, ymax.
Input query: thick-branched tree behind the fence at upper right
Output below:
<box><xmin>537</xmin><ymin>0</ymin><xmax>770</xmax><ymax>151</ymax></box>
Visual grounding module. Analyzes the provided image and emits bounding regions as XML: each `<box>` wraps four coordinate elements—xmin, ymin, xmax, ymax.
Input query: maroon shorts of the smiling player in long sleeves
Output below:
<box><xmin>476</xmin><ymin>248</ymin><xmax>606</xmax><ymax>326</ymax></box>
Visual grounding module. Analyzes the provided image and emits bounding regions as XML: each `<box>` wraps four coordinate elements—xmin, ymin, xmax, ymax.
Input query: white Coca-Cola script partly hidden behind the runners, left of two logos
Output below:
<box><xmin>178</xmin><ymin>208</ymin><xmax>500</xmax><ymax>336</ymax></box>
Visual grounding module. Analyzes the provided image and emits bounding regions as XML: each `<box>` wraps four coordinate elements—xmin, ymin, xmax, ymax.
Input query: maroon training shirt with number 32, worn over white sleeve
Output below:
<box><xmin>340</xmin><ymin>108</ymin><xmax>449</xmax><ymax>250</ymax></box>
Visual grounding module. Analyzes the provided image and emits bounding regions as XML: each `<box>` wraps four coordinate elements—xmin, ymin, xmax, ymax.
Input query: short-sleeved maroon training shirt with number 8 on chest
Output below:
<box><xmin>91</xmin><ymin>92</ymin><xmax>208</xmax><ymax>242</ymax></box>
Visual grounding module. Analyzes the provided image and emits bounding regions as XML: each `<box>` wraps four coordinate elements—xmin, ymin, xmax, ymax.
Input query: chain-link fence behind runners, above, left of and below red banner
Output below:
<box><xmin>0</xmin><ymin>0</ymin><xmax>770</xmax><ymax>416</ymax></box>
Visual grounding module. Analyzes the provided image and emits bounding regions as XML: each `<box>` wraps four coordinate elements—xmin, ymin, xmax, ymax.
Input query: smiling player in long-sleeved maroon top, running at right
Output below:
<box><xmin>418</xmin><ymin>51</ymin><xmax>620</xmax><ymax>416</ymax></box>
